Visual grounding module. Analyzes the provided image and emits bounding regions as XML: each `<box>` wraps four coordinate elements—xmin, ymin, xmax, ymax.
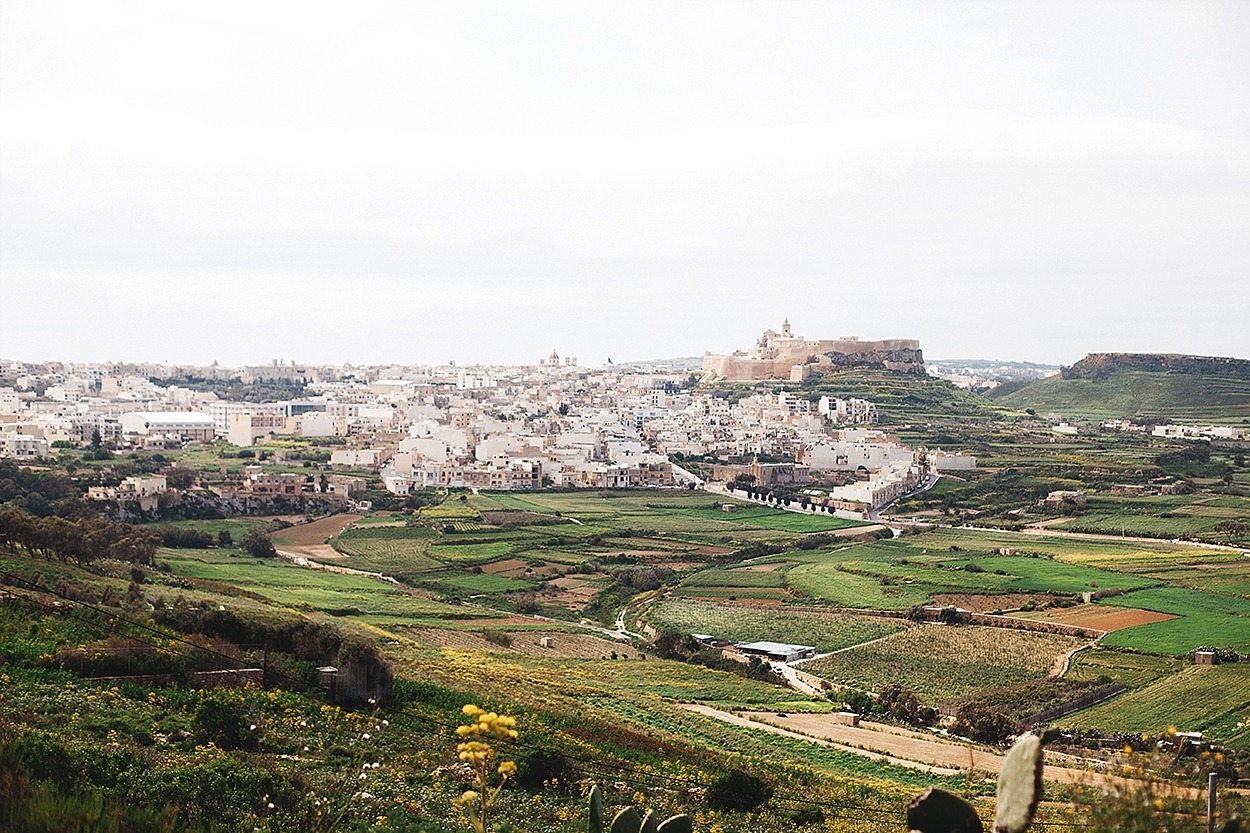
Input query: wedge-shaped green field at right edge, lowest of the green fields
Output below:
<box><xmin>1061</xmin><ymin>663</ymin><xmax>1250</xmax><ymax>747</ymax></box>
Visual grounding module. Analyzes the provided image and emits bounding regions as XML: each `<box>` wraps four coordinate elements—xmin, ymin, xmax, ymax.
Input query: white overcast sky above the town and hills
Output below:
<box><xmin>0</xmin><ymin>0</ymin><xmax>1250</xmax><ymax>364</ymax></box>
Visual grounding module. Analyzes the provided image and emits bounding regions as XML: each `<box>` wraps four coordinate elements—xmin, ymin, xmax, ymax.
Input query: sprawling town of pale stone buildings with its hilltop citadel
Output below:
<box><xmin>0</xmin><ymin>321</ymin><xmax>975</xmax><ymax>515</ymax></box>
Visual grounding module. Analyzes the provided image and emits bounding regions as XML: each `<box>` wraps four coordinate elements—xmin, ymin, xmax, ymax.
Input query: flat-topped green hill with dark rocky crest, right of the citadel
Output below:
<box><xmin>989</xmin><ymin>353</ymin><xmax>1250</xmax><ymax>423</ymax></box>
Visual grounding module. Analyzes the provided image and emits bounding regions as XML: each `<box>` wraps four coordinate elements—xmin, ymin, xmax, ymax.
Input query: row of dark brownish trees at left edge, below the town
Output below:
<box><xmin>0</xmin><ymin>509</ymin><xmax>161</xmax><ymax>564</ymax></box>
